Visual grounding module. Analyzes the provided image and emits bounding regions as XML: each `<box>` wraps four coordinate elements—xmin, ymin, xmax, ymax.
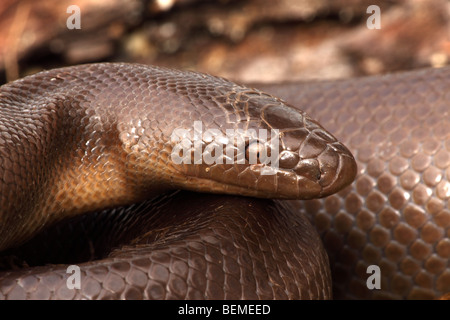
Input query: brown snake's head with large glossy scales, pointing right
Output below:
<box><xmin>167</xmin><ymin>87</ymin><xmax>356</xmax><ymax>199</ymax></box>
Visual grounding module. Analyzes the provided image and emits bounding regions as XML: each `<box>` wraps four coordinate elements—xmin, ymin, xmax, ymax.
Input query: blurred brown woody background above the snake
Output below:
<box><xmin>0</xmin><ymin>0</ymin><xmax>450</xmax><ymax>83</ymax></box>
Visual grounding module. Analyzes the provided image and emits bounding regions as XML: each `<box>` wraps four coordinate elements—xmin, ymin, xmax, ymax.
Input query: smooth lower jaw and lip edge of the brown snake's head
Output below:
<box><xmin>174</xmin><ymin>150</ymin><xmax>356</xmax><ymax>200</ymax></box>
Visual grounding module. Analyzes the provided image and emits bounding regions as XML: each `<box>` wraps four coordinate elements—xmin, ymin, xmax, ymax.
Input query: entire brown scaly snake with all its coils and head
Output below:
<box><xmin>0</xmin><ymin>64</ymin><xmax>450</xmax><ymax>299</ymax></box>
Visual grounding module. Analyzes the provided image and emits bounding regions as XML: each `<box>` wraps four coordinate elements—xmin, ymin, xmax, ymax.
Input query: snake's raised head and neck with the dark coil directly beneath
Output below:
<box><xmin>0</xmin><ymin>64</ymin><xmax>356</xmax><ymax>299</ymax></box>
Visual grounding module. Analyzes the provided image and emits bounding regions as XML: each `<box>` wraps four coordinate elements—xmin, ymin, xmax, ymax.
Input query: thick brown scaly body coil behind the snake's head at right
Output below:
<box><xmin>259</xmin><ymin>67</ymin><xmax>450</xmax><ymax>299</ymax></box>
